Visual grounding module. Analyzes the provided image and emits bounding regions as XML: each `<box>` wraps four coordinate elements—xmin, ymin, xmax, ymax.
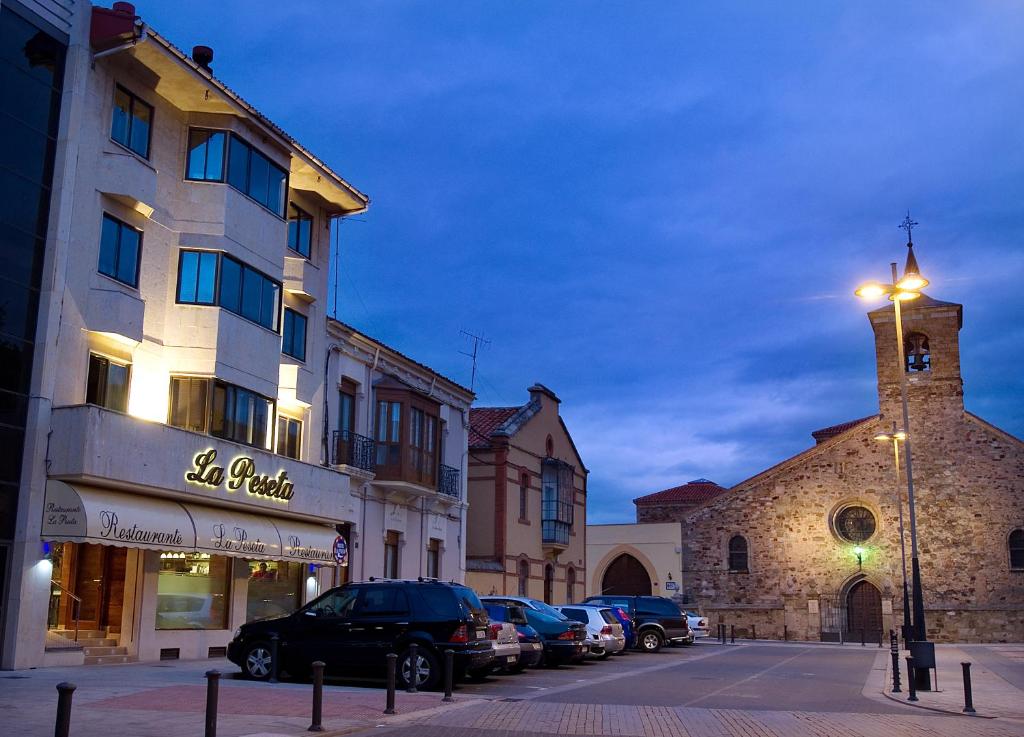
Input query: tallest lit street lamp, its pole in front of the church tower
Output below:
<box><xmin>855</xmin><ymin>223</ymin><xmax>928</xmax><ymax>655</ymax></box>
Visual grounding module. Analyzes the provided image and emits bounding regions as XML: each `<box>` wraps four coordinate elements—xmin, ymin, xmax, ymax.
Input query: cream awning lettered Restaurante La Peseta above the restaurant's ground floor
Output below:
<box><xmin>42</xmin><ymin>479</ymin><xmax>337</xmax><ymax>565</ymax></box>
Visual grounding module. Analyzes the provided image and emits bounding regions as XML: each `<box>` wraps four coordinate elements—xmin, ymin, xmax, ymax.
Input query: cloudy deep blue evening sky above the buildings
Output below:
<box><xmin>144</xmin><ymin>0</ymin><xmax>1024</xmax><ymax>522</ymax></box>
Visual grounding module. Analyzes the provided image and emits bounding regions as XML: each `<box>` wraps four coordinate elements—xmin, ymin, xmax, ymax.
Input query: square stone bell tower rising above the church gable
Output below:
<box><xmin>867</xmin><ymin>241</ymin><xmax>964</xmax><ymax>424</ymax></box>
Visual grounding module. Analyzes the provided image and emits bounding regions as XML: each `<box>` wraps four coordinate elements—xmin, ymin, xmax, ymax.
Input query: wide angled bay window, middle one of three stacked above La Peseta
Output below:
<box><xmin>177</xmin><ymin>249</ymin><xmax>280</xmax><ymax>331</ymax></box>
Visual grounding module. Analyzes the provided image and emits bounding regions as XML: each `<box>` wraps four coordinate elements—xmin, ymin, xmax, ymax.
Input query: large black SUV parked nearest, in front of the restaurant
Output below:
<box><xmin>227</xmin><ymin>579</ymin><xmax>494</xmax><ymax>689</ymax></box>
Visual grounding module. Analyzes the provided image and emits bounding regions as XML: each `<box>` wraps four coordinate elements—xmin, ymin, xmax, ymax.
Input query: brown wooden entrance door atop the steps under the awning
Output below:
<box><xmin>72</xmin><ymin>543</ymin><xmax>128</xmax><ymax>632</ymax></box>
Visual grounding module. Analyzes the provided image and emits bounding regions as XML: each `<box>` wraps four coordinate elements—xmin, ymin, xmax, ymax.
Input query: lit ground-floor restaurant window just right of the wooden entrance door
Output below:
<box><xmin>157</xmin><ymin>553</ymin><xmax>231</xmax><ymax>630</ymax></box>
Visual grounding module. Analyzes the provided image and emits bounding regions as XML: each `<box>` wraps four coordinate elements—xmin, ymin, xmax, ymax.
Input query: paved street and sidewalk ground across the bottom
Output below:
<box><xmin>0</xmin><ymin>642</ymin><xmax>1024</xmax><ymax>737</ymax></box>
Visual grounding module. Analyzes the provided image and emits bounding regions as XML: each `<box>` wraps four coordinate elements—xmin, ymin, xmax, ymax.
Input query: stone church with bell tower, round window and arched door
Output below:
<box><xmin>593</xmin><ymin>255</ymin><xmax>1024</xmax><ymax>642</ymax></box>
